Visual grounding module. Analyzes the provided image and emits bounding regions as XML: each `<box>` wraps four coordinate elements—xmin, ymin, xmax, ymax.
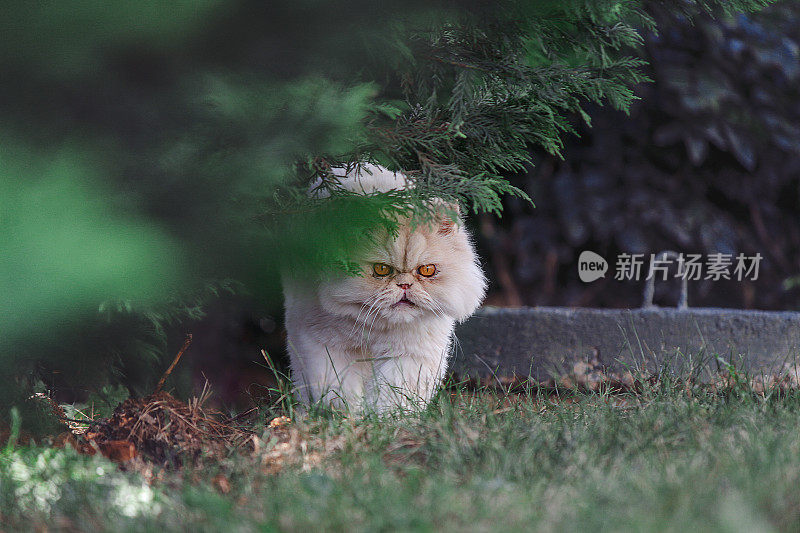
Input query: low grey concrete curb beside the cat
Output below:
<box><xmin>451</xmin><ymin>307</ymin><xmax>800</xmax><ymax>381</ymax></box>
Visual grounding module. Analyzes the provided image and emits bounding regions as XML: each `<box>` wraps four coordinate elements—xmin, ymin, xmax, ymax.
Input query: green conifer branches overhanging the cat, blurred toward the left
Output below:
<box><xmin>0</xmin><ymin>0</ymin><xmax>776</xmax><ymax>422</ymax></box>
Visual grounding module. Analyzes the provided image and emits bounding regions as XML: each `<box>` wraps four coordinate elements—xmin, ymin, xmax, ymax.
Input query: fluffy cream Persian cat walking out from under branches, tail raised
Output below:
<box><xmin>284</xmin><ymin>164</ymin><xmax>486</xmax><ymax>413</ymax></box>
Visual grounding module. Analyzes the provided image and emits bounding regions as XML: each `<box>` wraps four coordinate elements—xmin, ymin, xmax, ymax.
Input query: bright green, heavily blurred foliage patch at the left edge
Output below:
<box><xmin>0</xmin><ymin>142</ymin><xmax>182</xmax><ymax>351</ymax></box>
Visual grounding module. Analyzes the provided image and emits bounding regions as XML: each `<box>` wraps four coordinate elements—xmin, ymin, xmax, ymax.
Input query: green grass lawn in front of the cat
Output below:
<box><xmin>0</xmin><ymin>386</ymin><xmax>800</xmax><ymax>532</ymax></box>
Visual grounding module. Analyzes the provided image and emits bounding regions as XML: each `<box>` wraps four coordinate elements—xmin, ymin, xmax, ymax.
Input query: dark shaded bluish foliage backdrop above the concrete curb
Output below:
<box><xmin>481</xmin><ymin>2</ymin><xmax>800</xmax><ymax>309</ymax></box>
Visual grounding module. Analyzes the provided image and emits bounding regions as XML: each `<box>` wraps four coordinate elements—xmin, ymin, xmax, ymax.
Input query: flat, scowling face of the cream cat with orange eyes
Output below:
<box><xmin>319</xmin><ymin>215</ymin><xmax>486</xmax><ymax>327</ymax></box>
